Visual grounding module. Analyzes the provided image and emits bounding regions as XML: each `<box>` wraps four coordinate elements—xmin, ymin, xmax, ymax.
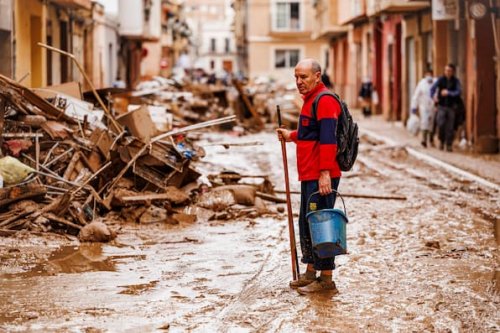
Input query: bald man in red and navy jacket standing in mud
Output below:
<box><xmin>276</xmin><ymin>59</ymin><xmax>341</xmax><ymax>294</ymax></box>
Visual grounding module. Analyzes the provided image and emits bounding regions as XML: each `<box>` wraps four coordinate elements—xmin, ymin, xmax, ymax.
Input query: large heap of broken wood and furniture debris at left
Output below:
<box><xmin>0</xmin><ymin>75</ymin><xmax>278</xmax><ymax>240</ymax></box>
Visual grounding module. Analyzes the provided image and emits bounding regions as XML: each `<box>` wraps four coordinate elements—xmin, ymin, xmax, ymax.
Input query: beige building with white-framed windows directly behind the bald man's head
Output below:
<box><xmin>246</xmin><ymin>0</ymin><xmax>328</xmax><ymax>82</ymax></box>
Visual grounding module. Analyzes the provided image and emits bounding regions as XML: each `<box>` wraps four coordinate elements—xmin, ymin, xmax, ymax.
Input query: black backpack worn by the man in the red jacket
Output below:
<box><xmin>311</xmin><ymin>91</ymin><xmax>359</xmax><ymax>171</ymax></box>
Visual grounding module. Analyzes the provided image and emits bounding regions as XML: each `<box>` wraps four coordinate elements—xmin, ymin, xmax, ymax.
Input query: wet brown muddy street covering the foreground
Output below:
<box><xmin>0</xmin><ymin>132</ymin><xmax>500</xmax><ymax>332</ymax></box>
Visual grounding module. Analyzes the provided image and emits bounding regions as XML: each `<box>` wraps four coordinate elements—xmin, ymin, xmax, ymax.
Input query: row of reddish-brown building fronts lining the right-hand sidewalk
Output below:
<box><xmin>313</xmin><ymin>0</ymin><xmax>500</xmax><ymax>153</ymax></box>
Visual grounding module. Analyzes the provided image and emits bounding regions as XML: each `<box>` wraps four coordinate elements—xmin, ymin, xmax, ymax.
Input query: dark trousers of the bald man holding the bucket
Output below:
<box><xmin>299</xmin><ymin>178</ymin><xmax>340</xmax><ymax>271</ymax></box>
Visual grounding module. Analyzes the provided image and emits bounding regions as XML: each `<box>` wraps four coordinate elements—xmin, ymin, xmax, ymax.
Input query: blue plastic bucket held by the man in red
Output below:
<box><xmin>306</xmin><ymin>192</ymin><xmax>349</xmax><ymax>258</ymax></box>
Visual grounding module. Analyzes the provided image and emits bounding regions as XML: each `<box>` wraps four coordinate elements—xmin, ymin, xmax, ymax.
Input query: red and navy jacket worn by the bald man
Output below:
<box><xmin>290</xmin><ymin>83</ymin><xmax>341</xmax><ymax>181</ymax></box>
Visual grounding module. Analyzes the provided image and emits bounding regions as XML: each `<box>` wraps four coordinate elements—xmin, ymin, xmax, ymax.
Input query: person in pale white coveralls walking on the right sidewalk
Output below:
<box><xmin>411</xmin><ymin>70</ymin><xmax>436</xmax><ymax>147</ymax></box>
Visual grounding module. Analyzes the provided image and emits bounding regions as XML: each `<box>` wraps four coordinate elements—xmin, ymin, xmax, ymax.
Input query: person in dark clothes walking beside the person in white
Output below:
<box><xmin>430</xmin><ymin>64</ymin><xmax>462</xmax><ymax>151</ymax></box>
